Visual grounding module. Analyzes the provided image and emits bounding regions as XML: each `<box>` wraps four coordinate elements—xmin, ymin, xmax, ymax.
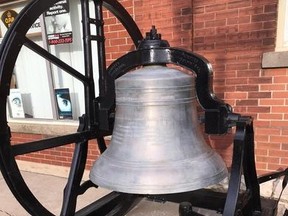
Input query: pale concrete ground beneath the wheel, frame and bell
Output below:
<box><xmin>0</xmin><ymin>171</ymin><xmax>219</xmax><ymax>216</ymax></box>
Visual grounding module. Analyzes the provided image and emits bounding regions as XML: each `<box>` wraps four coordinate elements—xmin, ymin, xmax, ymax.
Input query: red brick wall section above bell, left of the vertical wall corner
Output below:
<box><xmin>104</xmin><ymin>0</ymin><xmax>192</xmax><ymax>64</ymax></box>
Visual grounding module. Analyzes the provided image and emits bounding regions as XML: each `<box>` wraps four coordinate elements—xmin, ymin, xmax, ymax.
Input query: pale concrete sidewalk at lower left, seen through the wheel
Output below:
<box><xmin>0</xmin><ymin>171</ymin><xmax>113</xmax><ymax>216</ymax></box>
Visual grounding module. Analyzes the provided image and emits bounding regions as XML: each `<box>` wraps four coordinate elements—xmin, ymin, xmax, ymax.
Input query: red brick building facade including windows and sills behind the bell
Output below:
<box><xmin>0</xmin><ymin>0</ymin><xmax>288</xmax><ymax>182</ymax></box>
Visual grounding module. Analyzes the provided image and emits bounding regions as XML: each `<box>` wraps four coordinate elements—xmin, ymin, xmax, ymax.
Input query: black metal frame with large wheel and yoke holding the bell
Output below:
<box><xmin>0</xmin><ymin>0</ymin><xmax>287</xmax><ymax>216</ymax></box>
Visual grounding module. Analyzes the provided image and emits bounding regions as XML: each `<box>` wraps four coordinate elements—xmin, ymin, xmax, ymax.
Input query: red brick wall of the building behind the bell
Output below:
<box><xmin>11</xmin><ymin>0</ymin><xmax>288</xmax><ymax>176</ymax></box>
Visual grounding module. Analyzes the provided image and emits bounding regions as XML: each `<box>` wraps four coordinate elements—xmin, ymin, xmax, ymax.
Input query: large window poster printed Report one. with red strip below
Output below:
<box><xmin>45</xmin><ymin>0</ymin><xmax>73</xmax><ymax>45</ymax></box>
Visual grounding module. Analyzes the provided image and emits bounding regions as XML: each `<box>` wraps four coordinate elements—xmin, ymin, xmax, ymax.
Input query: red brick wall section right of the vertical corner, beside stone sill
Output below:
<box><xmin>193</xmin><ymin>0</ymin><xmax>280</xmax><ymax>173</ymax></box>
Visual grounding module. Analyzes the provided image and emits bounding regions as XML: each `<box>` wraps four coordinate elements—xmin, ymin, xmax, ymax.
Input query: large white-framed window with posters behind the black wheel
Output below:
<box><xmin>0</xmin><ymin>0</ymin><xmax>98</xmax><ymax>121</ymax></box>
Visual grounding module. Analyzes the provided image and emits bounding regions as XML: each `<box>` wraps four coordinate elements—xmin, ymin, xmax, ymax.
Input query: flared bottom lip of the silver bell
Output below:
<box><xmin>89</xmin><ymin>167</ymin><xmax>228</xmax><ymax>195</ymax></box>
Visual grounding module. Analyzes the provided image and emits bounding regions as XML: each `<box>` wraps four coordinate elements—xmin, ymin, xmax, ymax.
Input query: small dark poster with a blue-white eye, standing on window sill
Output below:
<box><xmin>55</xmin><ymin>88</ymin><xmax>72</xmax><ymax>119</ymax></box>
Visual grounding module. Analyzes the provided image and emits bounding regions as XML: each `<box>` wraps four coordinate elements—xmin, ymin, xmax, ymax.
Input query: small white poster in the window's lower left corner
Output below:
<box><xmin>8</xmin><ymin>89</ymin><xmax>25</xmax><ymax>118</ymax></box>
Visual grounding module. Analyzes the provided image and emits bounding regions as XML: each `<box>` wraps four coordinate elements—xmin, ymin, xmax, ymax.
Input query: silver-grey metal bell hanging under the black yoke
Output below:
<box><xmin>90</xmin><ymin>66</ymin><xmax>227</xmax><ymax>194</ymax></box>
